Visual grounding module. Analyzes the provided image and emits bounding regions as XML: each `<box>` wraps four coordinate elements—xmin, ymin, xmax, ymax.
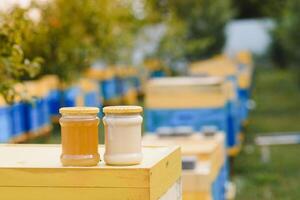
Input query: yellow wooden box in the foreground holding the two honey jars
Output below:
<box><xmin>0</xmin><ymin>145</ymin><xmax>181</xmax><ymax>200</ymax></box>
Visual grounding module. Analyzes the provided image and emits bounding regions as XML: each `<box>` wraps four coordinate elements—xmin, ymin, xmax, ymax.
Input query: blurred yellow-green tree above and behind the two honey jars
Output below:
<box><xmin>24</xmin><ymin>0</ymin><xmax>137</xmax><ymax>82</ymax></box>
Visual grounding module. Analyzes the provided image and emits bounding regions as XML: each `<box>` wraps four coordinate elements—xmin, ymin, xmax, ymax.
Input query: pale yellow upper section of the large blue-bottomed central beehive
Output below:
<box><xmin>145</xmin><ymin>77</ymin><xmax>227</xmax><ymax>109</ymax></box>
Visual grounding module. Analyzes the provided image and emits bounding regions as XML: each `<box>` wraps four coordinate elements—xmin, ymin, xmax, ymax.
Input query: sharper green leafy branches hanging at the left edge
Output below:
<box><xmin>0</xmin><ymin>9</ymin><xmax>41</xmax><ymax>103</ymax></box>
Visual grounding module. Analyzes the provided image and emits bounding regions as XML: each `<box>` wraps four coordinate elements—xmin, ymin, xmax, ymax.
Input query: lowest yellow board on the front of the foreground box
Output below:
<box><xmin>0</xmin><ymin>187</ymin><xmax>150</xmax><ymax>200</ymax></box>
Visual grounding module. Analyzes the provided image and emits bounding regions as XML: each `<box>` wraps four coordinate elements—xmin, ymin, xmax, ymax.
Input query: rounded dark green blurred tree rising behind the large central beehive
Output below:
<box><xmin>146</xmin><ymin>0</ymin><xmax>233</xmax><ymax>66</ymax></box>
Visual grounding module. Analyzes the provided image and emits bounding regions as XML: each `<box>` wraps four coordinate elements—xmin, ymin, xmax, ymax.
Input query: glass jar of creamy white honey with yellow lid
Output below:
<box><xmin>103</xmin><ymin>106</ymin><xmax>143</xmax><ymax>165</ymax></box>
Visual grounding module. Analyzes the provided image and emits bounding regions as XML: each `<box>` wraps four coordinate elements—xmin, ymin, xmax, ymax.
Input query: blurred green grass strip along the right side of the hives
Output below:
<box><xmin>234</xmin><ymin>68</ymin><xmax>300</xmax><ymax>200</ymax></box>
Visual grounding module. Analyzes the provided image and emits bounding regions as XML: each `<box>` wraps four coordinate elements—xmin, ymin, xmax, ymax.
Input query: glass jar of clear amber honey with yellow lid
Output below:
<box><xmin>59</xmin><ymin>107</ymin><xmax>100</xmax><ymax>166</ymax></box>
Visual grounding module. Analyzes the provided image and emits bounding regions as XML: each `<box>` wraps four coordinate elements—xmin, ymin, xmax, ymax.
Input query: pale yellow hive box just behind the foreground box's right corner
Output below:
<box><xmin>143</xmin><ymin>133</ymin><xmax>225</xmax><ymax>200</ymax></box>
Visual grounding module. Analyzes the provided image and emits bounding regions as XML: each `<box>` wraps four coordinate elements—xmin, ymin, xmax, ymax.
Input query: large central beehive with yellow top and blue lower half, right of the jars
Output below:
<box><xmin>145</xmin><ymin>77</ymin><xmax>238</xmax><ymax>148</ymax></box>
